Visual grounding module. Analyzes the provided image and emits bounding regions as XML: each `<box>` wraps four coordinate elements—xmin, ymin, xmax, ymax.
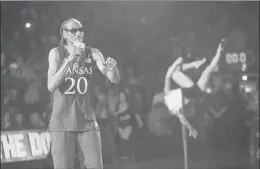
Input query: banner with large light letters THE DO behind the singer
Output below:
<box><xmin>1</xmin><ymin>130</ymin><xmax>51</xmax><ymax>163</ymax></box>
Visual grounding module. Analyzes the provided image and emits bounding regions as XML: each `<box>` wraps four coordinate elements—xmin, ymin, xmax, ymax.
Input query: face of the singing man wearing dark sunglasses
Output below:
<box><xmin>64</xmin><ymin>20</ymin><xmax>84</xmax><ymax>44</ymax></box>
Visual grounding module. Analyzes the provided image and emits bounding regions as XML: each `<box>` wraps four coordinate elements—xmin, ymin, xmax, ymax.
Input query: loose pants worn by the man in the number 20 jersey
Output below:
<box><xmin>51</xmin><ymin>130</ymin><xmax>103</xmax><ymax>169</ymax></box>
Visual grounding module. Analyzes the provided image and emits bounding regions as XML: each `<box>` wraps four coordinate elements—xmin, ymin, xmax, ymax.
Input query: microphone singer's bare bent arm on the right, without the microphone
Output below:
<box><xmin>92</xmin><ymin>49</ymin><xmax>120</xmax><ymax>84</ymax></box>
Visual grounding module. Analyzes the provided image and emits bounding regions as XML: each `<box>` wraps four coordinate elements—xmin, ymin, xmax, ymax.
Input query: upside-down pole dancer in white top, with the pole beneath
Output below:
<box><xmin>164</xmin><ymin>40</ymin><xmax>224</xmax><ymax>169</ymax></box>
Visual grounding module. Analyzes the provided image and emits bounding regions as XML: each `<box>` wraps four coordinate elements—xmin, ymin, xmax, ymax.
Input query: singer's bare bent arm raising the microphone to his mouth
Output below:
<box><xmin>47</xmin><ymin>48</ymin><xmax>71</xmax><ymax>92</ymax></box>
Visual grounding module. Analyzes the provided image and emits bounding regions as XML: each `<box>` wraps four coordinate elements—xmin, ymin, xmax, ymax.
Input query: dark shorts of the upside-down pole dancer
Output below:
<box><xmin>181</xmin><ymin>84</ymin><xmax>205</xmax><ymax>99</ymax></box>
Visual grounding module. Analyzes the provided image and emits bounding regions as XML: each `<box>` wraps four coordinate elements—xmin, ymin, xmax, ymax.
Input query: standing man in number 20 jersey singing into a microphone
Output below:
<box><xmin>48</xmin><ymin>18</ymin><xmax>120</xmax><ymax>169</ymax></box>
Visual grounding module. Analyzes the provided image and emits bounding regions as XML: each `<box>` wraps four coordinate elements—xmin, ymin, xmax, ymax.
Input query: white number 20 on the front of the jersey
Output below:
<box><xmin>64</xmin><ymin>77</ymin><xmax>88</xmax><ymax>94</ymax></box>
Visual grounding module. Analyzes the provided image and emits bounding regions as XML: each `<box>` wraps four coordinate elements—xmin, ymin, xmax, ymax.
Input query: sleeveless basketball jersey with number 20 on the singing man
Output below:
<box><xmin>49</xmin><ymin>48</ymin><xmax>98</xmax><ymax>131</ymax></box>
